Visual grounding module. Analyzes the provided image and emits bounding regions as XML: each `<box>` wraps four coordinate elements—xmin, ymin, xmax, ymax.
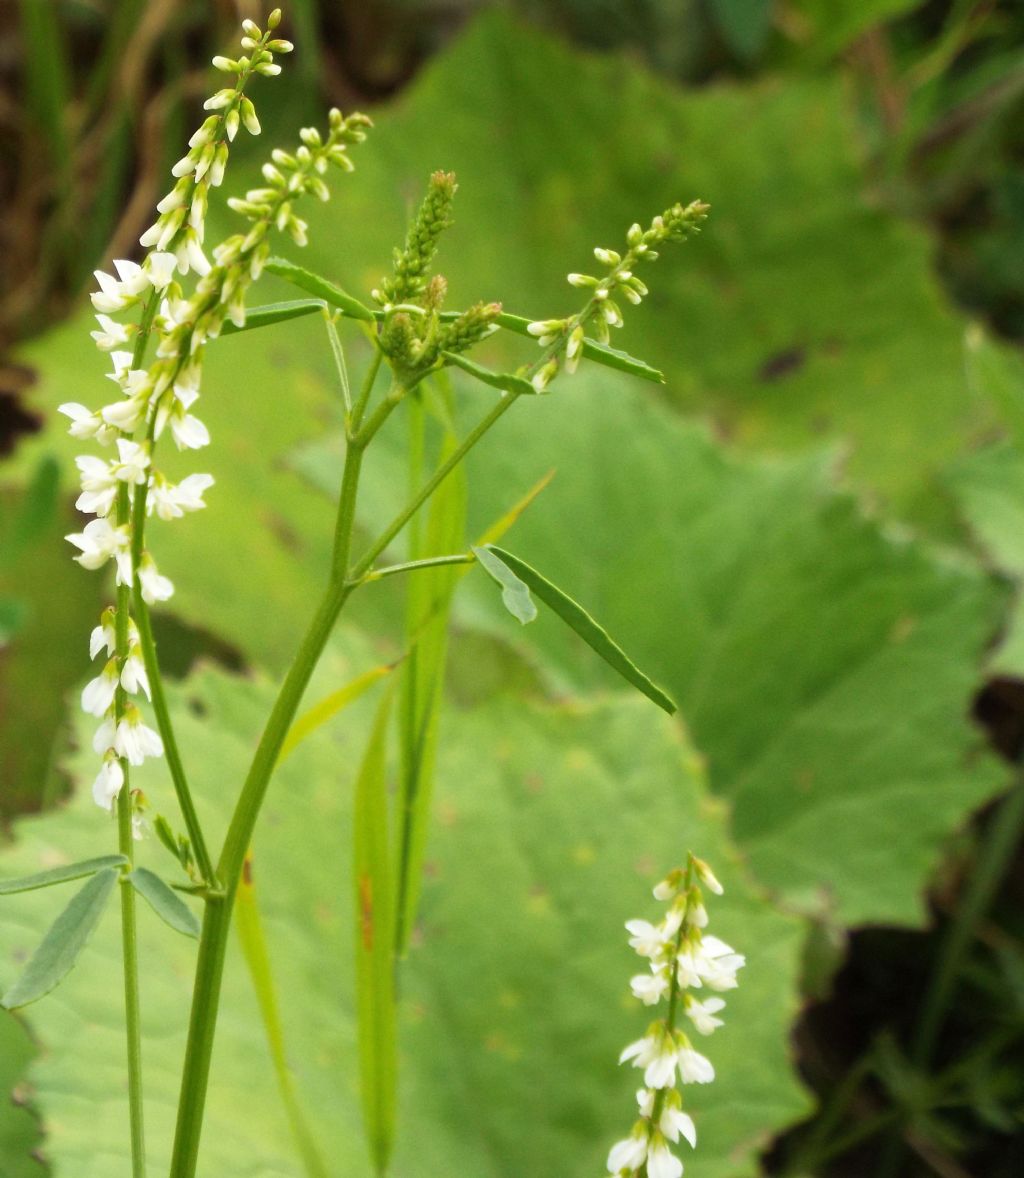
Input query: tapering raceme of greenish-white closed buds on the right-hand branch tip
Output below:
<box><xmin>527</xmin><ymin>200</ymin><xmax>708</xmax><ymax>392</ymax></box>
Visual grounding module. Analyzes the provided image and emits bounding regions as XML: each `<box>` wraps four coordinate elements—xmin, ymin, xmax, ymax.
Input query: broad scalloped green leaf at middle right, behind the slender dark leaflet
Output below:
<box><xmin>289</xmin><ymin>377</ymin><xmax>1005</xmax><ymax>922</ymax></box>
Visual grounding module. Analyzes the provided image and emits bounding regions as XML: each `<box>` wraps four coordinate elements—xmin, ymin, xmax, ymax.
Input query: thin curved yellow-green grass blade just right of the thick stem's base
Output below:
<box><xmin>234</xmin><ymin>851</ymin><xmax>330</xmax><ymax>1178</ymax></box>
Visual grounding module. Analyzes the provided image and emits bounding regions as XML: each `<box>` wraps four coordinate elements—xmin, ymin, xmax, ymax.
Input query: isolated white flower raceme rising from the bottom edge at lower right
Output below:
<box><xmin>608</xmin><ymin>855</ymin><xmax>746</xmax><ymax>1178</ymax></box>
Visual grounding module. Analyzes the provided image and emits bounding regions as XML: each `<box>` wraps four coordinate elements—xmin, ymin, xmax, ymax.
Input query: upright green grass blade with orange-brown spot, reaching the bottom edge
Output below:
<box><xmin>352</xmin><ymin>693</ymin><xmax>398</xmax><ymax>1174</ymax></box>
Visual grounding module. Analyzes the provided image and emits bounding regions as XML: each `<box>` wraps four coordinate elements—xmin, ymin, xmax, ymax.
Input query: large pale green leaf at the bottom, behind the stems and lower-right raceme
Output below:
<box><xmin>0</xmin><ymin>653</ymin><xmax>805</xmax><ymax>1178</ymax></box>
